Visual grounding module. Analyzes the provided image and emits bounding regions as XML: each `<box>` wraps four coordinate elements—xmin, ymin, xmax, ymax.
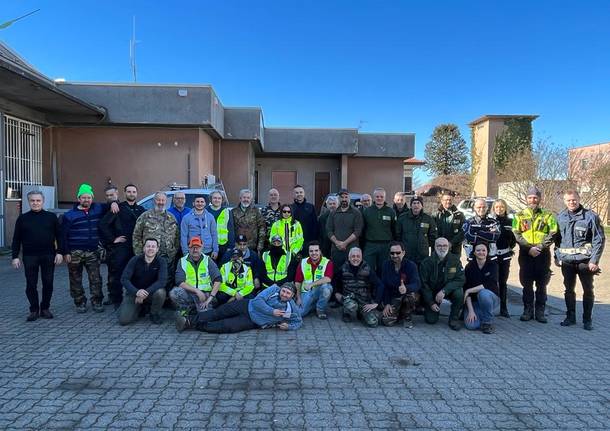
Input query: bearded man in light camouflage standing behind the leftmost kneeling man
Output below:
<box><xmin>133</xmin><ymin>192</ymin><xmax>180</xmax><ymax>296</ymax></box>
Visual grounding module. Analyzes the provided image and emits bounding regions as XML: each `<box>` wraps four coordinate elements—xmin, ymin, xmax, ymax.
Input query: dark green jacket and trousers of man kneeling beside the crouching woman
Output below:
<box><xmin>419</xmin><ymin>252</ymin><xmax>465</xmax><ymax>323</ymax></box>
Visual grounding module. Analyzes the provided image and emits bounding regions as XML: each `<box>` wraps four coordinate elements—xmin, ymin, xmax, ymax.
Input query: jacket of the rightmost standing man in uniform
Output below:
<box><xmin>555</xmin><ymin>206</ymin><xmax>606</xmax><ymax>264</ymax></box>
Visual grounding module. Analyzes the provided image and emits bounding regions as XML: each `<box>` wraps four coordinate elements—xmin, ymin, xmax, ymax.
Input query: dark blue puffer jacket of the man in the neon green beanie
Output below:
<box><xmin>61</xmin><ymin>202</ymin><xmax>109</xmax><ymax>254</ymax></box>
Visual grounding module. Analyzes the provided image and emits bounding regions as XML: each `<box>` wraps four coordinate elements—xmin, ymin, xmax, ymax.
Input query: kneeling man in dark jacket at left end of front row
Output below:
<box><xmin>119</xmin><ymin>238</ymin><xmax>167</xmax><ymax>325</ymax></box>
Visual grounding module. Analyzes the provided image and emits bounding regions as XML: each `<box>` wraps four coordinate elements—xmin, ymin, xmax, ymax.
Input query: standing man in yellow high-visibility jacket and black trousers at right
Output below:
<box><xmin>513</xmin><ymin>187</ymin><xmax>557</xmax><ymax>323</ymax></box>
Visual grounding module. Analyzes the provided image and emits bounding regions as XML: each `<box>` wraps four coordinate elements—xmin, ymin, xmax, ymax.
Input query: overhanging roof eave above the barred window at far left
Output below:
<box><xmin>0</xmin><ymin>42</ymin><xmax>106</xmax><ymax>123</ymax></box>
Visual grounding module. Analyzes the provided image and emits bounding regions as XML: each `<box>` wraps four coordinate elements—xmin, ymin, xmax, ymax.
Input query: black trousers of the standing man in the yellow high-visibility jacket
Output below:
<box><xmin>519</xmin><ymin>249</ymin><xmax>551</xmax><ymax>308</ymax></box>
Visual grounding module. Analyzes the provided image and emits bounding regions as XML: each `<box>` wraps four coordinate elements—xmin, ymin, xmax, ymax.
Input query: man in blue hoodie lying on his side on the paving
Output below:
<box><xmin>176</xmin><ymin>283</ymin><xmax>303</xmax><ymax>334</ymax></box>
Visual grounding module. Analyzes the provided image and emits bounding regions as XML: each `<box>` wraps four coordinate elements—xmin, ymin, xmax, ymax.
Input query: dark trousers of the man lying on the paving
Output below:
<box><xmin>193</xmin><ymin>299</ymin><xmax>258</xmax><ymax>334</ymax></box>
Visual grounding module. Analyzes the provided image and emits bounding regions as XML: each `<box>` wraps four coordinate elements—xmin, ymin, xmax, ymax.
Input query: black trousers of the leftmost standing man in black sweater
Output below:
<box><xmin>23</xmin><ymin>255</ymin><xmax>55</xmax><ymax>311</ymax></box>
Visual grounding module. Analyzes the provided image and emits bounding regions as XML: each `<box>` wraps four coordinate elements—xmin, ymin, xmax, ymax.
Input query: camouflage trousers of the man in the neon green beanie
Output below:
<box><xmin>68</xmin><ymin>250</ymin><xmax>104</xmax><ymax>305</ymax></box>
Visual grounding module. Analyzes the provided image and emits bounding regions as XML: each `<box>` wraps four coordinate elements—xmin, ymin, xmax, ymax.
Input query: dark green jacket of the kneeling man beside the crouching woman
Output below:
<box><xmin>419</xmin><ymin>252</ymin><xmax>466</xmax><ymax>307</ymax></box>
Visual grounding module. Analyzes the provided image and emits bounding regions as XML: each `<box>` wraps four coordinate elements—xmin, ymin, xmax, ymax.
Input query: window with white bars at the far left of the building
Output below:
<box><xmin>4</xmin><ymin>116</ymin><xmax>42</xmax><ymax>199</ymax></box>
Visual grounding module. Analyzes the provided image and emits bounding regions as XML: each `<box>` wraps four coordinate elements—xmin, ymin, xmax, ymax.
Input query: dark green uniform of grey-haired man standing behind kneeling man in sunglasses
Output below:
<box><xmin>362</xmin><ymin>203</ymin><xmax>396</xmax><ymax>274</ymax></box>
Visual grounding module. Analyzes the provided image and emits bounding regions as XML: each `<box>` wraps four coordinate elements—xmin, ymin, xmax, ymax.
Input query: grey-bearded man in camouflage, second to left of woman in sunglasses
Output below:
<box><xmin>232</xmin><ymin>189</ymin><xmax>267</xmax><ymax>254</ymax></box>
